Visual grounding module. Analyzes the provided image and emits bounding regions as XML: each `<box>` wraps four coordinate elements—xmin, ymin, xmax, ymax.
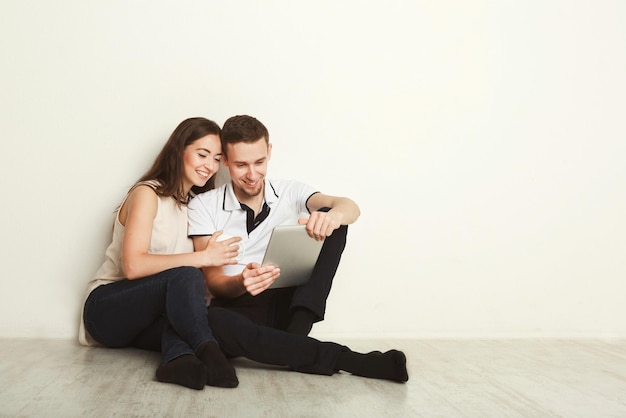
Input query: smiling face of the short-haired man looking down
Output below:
<box><xmin>223</xmin><ymin>138</ymin><xmax>272</xmax><ymax>203</ymax></box>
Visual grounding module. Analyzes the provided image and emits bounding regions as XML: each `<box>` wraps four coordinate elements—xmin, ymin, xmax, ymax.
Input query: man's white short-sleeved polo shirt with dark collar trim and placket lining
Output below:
<box><xmin>188</xmin><ymin>179</ymin><xmax>317</xmax><ymax>275</ymax></box>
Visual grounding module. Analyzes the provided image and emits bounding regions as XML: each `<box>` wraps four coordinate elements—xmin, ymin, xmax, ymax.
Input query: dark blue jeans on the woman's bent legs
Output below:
<box><xmin>83</xmin><ymin>267</ymin><xmax>215</xmax><ymax>364</ymax></box>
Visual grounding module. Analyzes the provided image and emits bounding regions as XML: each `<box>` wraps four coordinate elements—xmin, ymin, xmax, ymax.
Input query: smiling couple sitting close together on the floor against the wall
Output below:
<box><xmin>79</xmin><ymin>116</ymin><xmax>408</xmax><ymax>389</ymax></box>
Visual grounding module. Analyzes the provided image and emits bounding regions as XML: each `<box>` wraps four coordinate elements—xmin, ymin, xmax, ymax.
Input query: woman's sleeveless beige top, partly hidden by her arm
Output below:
<box><xmin>78</xmin><ymin>181</ymin><xmax>193</xmax><ymax>345</ymax></box>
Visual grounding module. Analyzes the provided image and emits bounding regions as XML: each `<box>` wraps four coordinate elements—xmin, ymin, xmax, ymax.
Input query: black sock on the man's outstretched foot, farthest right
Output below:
<box><xmin>336</xmin><ymin>350</ymin><xmax>409</xmax><ymax>383</ymax></box>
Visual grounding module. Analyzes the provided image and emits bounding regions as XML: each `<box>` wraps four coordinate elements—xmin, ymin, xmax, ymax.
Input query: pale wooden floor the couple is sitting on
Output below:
<box><xmin>0</xmin><ymin>339</ymin><xmax>626</xmax><ymax>418</ymax></box>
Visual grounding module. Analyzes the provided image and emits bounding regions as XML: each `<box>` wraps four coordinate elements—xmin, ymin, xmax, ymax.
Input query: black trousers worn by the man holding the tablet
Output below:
<box><xmin>197</xmin><ymin>226</ymin><xmax>349</xmax><ymax>375</ymax></box>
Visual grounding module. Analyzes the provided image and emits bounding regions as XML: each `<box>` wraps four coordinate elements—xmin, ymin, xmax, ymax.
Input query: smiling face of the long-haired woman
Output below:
<box><xmin>183</xmin><ymin>134</ymin><xmax>222</xmax><ymax>193</ymax></box>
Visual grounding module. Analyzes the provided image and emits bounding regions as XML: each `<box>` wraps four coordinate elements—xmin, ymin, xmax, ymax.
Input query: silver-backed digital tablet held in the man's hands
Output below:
<box><xmin>263</xmin><ymin>225</ymin><xmax>324</xmax><ymax>289</ymax></box>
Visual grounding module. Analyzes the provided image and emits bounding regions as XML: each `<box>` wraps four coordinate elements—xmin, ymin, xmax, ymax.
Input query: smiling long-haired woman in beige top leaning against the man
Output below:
<box><xmin>79</xmin><ymin>118</ymin><xmax>239</xmax><ymax>389</ymax></box>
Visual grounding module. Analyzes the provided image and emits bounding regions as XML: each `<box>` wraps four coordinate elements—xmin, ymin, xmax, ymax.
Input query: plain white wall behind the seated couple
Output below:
<box><xmin>0</xmin><ymin>0</ymin><xmax>626</xmax><ymax>338</ymax></box>
